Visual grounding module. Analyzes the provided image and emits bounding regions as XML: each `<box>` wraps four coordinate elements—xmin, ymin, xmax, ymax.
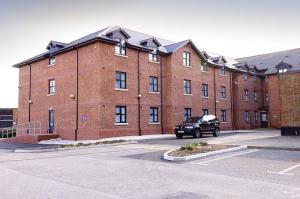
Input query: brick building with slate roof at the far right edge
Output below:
<box><xmin>237</xmin><ymin>49</ymin><xmax>300</xmax><ymax>135</ymax></box>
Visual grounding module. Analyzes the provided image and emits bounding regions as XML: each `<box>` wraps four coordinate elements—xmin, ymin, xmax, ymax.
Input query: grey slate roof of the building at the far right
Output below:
<box><xmin>237</xmin><ymin>48</ymin><xmax>300</xmax><ymax>75</ymax></box>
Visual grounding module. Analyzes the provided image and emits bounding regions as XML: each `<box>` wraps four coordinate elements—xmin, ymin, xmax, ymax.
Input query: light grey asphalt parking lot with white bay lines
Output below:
<box><xmin>0</xmin><ymin>131</ymin><xmax>300</xmax><ymax>199</ymax></box>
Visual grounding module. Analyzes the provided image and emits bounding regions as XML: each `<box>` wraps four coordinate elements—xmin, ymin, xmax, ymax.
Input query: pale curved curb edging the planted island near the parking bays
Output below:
<box><xmin>163</xmin><ymin>145</ymin><xmax>248</xmax><ymax>162</ymax></box>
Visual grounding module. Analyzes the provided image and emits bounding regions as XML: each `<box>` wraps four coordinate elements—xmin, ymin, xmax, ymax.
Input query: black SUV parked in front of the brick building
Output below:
<box><xmin>174</xmin><ymin>115</ymin><xmax>220</xmax><ymax>138</ymax></box>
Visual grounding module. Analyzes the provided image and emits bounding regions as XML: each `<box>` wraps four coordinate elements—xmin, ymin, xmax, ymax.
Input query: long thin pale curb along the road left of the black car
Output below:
<box><xmin>14</xmin><ymin>141</ymin><xmax>137</xmax><ymax>153</ymax></box>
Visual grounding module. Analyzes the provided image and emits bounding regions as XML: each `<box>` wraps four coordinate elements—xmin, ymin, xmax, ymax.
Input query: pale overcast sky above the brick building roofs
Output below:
<box><xmin>0</xmin><ymin>0</ymin><xmax>300</xmax><ymax>107</ymax></box>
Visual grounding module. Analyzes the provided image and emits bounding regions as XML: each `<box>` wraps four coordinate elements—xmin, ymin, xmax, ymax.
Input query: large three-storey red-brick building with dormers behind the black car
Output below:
<box><xmin>14</xmin><ymin>26</ymin><xmax>300</xmax><ymax>139</ymax></box>
